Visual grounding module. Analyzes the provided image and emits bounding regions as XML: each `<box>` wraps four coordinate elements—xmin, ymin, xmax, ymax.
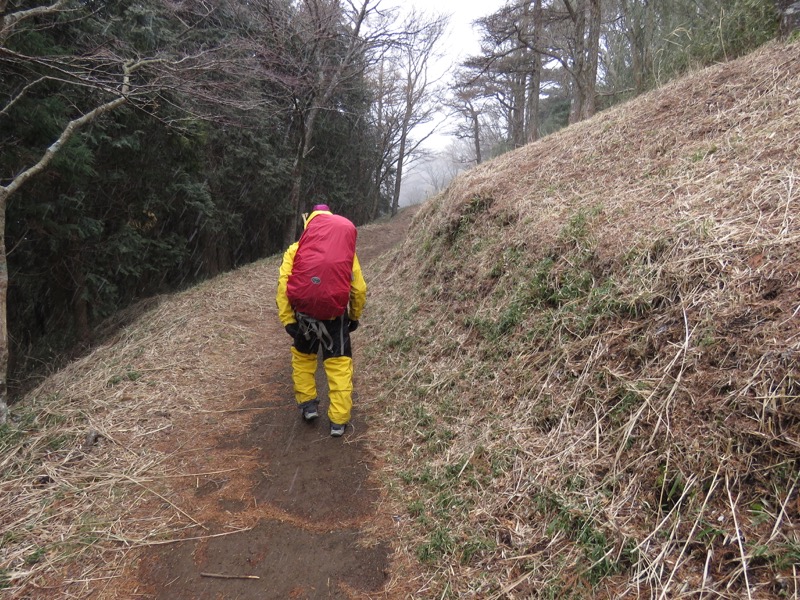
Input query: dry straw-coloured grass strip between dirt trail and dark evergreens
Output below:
<box><xmin>0</xmin><ymin>265</ymin><xmax>276</xmax><ymax>598</ymax></box>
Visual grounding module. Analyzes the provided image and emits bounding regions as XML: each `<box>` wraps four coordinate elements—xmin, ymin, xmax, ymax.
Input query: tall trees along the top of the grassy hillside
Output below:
<box><xmin>448</xmin><ymin>0</ymin><xmax>785</xmax><ymax>162</ymax></box>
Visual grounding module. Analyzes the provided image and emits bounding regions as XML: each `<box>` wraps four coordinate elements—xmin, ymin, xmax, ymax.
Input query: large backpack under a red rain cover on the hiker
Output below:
<box><xmin>286</xmin><ymin>213</ymin><xmax>357</xmax><ymax>321</ymax></box>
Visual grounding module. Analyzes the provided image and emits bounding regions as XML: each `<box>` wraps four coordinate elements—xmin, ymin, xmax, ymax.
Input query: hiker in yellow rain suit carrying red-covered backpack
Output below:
<box><xmin>276</xmin><ymin>204</ymin><xmax>367</xmax><ymax>437</ymax></box>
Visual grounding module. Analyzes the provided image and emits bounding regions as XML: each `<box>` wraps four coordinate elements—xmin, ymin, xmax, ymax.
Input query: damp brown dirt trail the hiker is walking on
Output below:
<box><xmin>113</xmin><ymin>210</ymin><xmax>422</xmax><ymax>600</ymax></box>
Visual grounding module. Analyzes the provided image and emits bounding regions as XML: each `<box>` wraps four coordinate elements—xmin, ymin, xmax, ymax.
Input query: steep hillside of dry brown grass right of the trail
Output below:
<box><xmin>364</xmin><ymin>39</ymin><xmax>800</xmax><ymax>598</ymax></box>
